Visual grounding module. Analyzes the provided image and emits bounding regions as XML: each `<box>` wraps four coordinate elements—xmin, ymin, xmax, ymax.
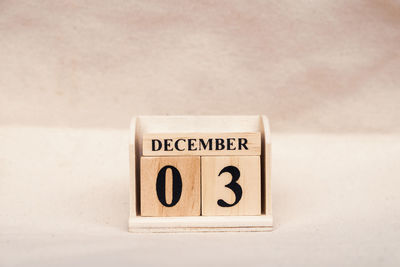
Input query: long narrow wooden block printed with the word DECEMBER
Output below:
<box><xmin>143</xmin><ymin>132</ymin><xmax>261</xmax><ymax>156</ymax></box>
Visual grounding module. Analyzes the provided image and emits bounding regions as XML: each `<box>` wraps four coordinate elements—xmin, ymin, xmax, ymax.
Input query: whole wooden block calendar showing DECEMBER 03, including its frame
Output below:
<box><xmin>129</xmin><ymin>116</ymin><xmax>272</xmax><ymax>232</ymax></box>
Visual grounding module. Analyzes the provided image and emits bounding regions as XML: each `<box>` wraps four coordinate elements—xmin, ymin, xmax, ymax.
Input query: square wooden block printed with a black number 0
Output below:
<box><xmin>140</xmin><ymin>156</ymin><xmax>200</xmax><ymax>217</ymax></box>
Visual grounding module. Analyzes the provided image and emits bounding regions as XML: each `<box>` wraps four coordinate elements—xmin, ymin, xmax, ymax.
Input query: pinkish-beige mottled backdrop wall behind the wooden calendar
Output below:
<box><xmin>0</xmin><ymin>0</ymin><xmax>400</xmax><ymax>132</ymax></box>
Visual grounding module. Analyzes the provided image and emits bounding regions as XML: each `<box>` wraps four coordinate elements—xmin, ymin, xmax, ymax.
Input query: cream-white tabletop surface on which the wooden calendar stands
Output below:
<box><xmin>0</xmin><ymin>127</ymin><xmax>400</xmax><ymax>266</ymax></box>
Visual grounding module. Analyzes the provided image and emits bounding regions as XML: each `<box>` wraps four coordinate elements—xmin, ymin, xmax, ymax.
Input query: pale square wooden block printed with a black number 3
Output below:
<box><xmin>201</xmin><ymin>156</ymin><xmax>261</xmax><ymax>216</ymax></box>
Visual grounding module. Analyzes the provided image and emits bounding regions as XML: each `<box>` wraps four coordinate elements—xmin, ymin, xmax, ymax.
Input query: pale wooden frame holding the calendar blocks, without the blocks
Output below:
<box><xmin>129</xmin><ymin>115</ymin><xmax>273</xmax><ymax>233</ymax></box>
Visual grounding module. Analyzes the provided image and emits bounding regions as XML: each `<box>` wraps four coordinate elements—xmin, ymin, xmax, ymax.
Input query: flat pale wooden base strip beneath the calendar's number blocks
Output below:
<box><xmin>129</xmin><ymin>215</ymin><xmax>272</xmax><ymax>233</ymax></box>
